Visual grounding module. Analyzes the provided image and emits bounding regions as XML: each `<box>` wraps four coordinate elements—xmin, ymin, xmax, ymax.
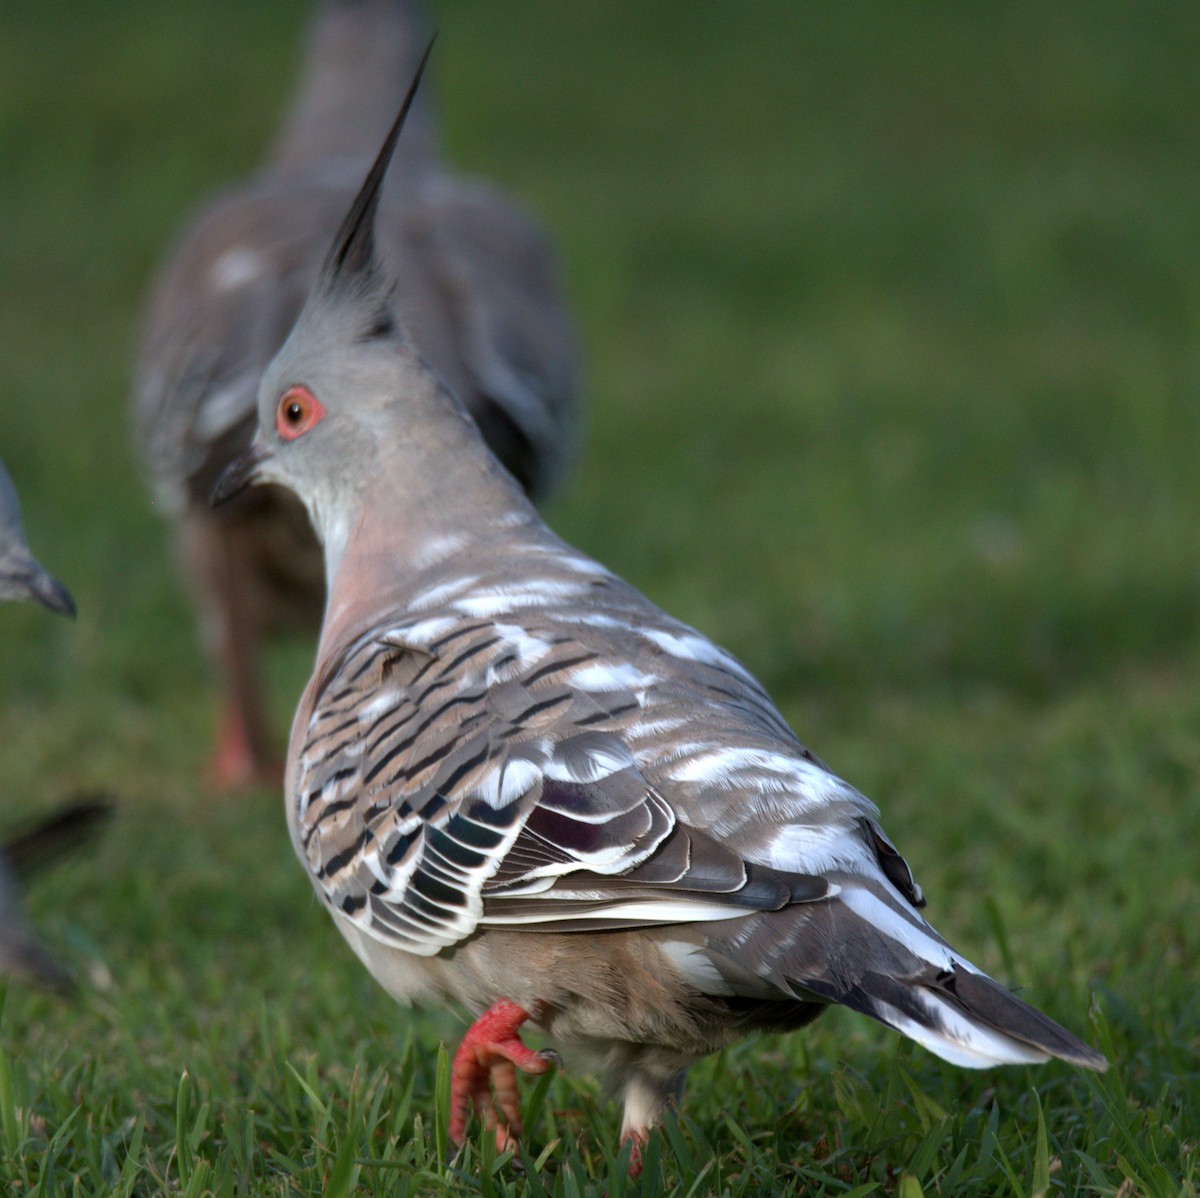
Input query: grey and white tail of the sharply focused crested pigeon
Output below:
<box><xmin>780</xmin><ymin>879</ymin><xmax>1108</xmax><ymax>1070</ymax></box>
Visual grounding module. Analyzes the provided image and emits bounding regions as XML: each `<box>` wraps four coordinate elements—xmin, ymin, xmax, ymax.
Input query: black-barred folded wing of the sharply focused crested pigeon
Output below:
<box><xmin>289</xmin><ymin>618</ymin><xmax>830</xmax><ymax>954</ymax></box>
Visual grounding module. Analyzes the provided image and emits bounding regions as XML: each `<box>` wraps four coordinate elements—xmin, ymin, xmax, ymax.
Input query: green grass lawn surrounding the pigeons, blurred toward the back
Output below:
<box><xmin>0</xmin><ymin>0</ymin><xmax>1200</xmax><ymax>1198</ymax></box>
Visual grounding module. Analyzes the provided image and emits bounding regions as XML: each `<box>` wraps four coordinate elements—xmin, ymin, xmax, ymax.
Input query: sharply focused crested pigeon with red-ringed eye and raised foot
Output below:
<box><xmin>214</xmin><ymin>56</ymin><xmax>1108</xmax><ymax>1172</ymax></box>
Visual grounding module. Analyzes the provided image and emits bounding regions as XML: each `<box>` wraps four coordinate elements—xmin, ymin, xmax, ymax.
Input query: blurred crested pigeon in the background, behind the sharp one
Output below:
<box><xmin>134</xmin><ymin>0</ymin><xmax>578</xmax><ymax>786</ymax></box>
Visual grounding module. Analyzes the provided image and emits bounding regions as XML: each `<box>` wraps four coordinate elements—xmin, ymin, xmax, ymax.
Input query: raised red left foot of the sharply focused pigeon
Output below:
<box><xmin>450</xmin><ymin>999</ymin><xmax>554</xmax><ymax>1151</ymax></box>
